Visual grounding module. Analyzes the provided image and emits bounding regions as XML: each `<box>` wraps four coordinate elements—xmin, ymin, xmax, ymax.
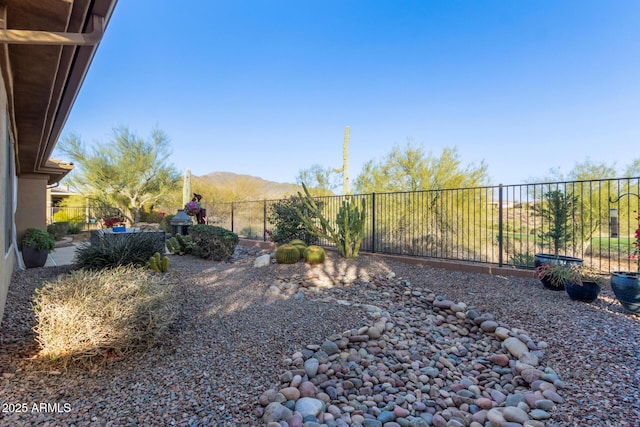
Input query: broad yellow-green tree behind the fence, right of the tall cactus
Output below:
<box><xmin>355</xmin><ymin>142</ymin><xmax>488</xmax><ymax>256</ymax></box>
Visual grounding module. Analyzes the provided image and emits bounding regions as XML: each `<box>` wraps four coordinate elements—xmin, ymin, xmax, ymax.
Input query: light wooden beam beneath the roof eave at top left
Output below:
<box><xmin>0</xmin><ymin>15</ymin><xmax>104</xmax><ymax>46</ymax></box>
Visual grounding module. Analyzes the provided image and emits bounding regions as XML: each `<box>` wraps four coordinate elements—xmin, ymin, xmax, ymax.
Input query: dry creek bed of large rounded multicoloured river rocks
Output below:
<box><xmin>256</xmin><ymin>273</ymin><xmax>564</xmax><ymax>427</ymax></box>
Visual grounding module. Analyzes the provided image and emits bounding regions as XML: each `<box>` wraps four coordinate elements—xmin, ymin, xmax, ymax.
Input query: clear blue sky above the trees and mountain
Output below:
<box><xmin>57</xmin><ymin>0</ymin><xmax>640</xmax><ymax>184</ymax></box>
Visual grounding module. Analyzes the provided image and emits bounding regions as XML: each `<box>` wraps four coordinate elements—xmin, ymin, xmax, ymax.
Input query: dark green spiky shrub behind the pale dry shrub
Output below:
<box><xmin>74</xmin><ymin>233</ymin><xmax>158</xmax><ymax>270</ymax></box>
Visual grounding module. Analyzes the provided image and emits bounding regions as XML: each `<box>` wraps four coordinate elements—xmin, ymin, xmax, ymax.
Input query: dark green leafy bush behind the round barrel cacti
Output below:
<box><xmin>267</xmin><ymin>196</ymin><xmax>322</xmax><ymax>245</ymax></box>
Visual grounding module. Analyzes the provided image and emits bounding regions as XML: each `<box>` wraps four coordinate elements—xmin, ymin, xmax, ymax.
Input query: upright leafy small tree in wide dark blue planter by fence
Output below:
<box><xmin>533</xmin><ymin>190</ymin><xmax>582</xmax><ymax>291</ymax></box>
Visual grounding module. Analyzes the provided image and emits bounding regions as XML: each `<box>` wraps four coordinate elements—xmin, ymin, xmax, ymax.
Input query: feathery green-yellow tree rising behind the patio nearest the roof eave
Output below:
<box><xmin>58</xmin><ymin>127</ymin><xmax>180</xmax><ymax>222</ymax></box>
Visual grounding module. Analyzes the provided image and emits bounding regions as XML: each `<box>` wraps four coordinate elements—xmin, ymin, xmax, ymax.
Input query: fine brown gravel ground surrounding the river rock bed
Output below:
<box><xmin>0</xmin><ymin>249</ymin><xmax>640</xmax><ymax>427</ymax></box>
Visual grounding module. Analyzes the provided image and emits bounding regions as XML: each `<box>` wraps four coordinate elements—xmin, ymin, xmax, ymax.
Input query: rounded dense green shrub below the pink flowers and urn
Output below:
<box><xmin>189</xmin><ymin>224</ymin><xmax>239</xmax><ymax>261</ymax></box>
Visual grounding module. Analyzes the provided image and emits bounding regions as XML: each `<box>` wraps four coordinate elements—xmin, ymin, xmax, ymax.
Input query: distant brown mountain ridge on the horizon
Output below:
<box><xmin>194</xmin><ymin>172</ymin><xmax>302</xmax><ymax>199</ymax></box>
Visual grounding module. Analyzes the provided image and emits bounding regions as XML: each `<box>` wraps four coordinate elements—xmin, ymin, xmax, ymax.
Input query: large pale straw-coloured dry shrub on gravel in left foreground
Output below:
<box><xmin>34</xmin><ymin>266</ymin><xmax>174</xmax><ymax>363</ymax></box>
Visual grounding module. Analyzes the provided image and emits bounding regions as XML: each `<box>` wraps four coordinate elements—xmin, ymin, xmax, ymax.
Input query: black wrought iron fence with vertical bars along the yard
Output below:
<box><xmin>53</xmin><ymin>177</ymin><xmax>640</xmax><ymax>272</ymax></box>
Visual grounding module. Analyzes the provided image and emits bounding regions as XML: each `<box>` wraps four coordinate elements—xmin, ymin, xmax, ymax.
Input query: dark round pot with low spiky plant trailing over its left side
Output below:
<box><xmin>535</xmin><ymin>263</ymin><xmax>606</xmax><ymax>302</ymax></box>
